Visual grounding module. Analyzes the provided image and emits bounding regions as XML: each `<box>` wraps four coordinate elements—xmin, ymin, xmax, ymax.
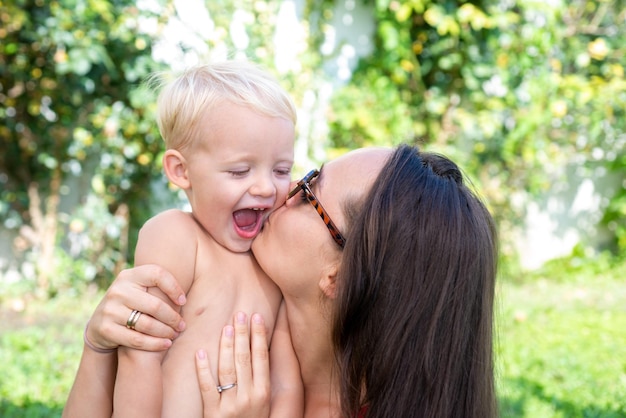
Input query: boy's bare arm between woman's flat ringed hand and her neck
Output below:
<box><xmin>270</xmin><ymin>301</ymin><xmax>304</xmax><ymax>418</ymax></box>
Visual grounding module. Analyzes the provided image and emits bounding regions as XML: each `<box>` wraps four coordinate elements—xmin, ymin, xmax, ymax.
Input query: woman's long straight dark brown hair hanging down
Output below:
<box><xmin>333</xmin><ymin>145</ymin><xmax>497</xmax><ymax>418</ymax></box>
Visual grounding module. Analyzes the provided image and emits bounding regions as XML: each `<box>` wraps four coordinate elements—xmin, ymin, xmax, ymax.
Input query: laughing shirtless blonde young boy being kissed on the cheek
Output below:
<box><xmin>113</xmin><ymin>61</ymin><xmax>296</xmax><ymax>417</ymax></box>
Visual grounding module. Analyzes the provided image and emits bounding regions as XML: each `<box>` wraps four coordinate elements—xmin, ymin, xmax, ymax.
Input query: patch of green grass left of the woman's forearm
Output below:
<box><xmin>0</xmin><ymin>292</ymin><xmax>94</xmax><ymax>418</ymax></box>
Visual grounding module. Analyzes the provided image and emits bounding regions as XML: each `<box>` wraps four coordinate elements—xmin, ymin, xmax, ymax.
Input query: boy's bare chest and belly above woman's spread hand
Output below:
<box><xmin>157</xmin><ymin>248</ymin><xmax>281</xmax><ymax>416</ymax></box>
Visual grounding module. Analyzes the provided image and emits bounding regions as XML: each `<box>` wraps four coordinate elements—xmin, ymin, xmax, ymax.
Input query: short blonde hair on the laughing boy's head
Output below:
<box><xmin>157</xmin><ymin>60</ymin><xmax>297</xmax><ymax>149</ymax></box>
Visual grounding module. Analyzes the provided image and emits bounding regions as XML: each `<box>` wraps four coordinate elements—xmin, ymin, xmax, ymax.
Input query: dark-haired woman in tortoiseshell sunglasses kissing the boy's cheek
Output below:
<box><xmin>63</xmin><ymin>146</ymin><xmax>497</xmax><ymax>418</ymax></box>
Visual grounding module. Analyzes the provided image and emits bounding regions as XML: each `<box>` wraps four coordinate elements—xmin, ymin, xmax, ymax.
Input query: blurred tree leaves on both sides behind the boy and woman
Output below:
<box><xmin>0</xmin><ymin>0</ymin><xmax>626</xmax><ymax>296</ymax></box>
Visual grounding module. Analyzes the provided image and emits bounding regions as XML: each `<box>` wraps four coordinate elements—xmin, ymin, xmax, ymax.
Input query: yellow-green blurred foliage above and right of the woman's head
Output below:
<box><xmin>330</xmin><ymin>0</ymin><xmax>626</xmax><ymax>256</ymax></box>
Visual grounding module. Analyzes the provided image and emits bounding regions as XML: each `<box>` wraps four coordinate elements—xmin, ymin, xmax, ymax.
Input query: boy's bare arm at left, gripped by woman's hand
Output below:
<box><xmin>113</xmin><ymin>211</ymin><xmax>197</xmax><ymax>416</ymax></box>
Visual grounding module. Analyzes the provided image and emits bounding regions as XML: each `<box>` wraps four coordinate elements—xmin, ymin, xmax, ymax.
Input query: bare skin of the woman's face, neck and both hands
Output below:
<box><xmin>63</xmin><ymin>149</ymin><xmax>391</xmax><ymax>418</ymax></box>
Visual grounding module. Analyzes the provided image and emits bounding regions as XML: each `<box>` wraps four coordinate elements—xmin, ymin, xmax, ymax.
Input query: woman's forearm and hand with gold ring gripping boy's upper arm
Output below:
<box><xmin>63</xmin><ymin>265</ymin><xmax>185</xmax><ymax>418</ymax></box>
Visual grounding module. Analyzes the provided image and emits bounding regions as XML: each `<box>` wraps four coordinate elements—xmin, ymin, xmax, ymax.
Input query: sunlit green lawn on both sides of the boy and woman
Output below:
<box><xmin>0</xmin><ymin>264</ymin><xmax>626</xmax><ymax>418</ymax></box>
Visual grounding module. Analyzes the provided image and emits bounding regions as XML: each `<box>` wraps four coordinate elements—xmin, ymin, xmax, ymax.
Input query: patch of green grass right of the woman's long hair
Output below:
<box><xmin>496</xmin><ymin>260</ymin><xmax>626</xmax><ymax>418</ymax></box>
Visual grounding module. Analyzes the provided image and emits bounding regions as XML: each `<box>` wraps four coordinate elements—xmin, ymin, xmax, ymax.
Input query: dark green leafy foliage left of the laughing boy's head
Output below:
<box><xmin>0</xmin><ymin>0</ymin><xmax>172</xmax><ymax>291</ymax></box>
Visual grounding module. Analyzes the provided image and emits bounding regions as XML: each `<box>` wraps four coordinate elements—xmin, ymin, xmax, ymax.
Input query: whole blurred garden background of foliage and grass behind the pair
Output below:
<box><xmin>0</xmin><ymin>0</ymin><xmax>626</xmax><ymax>417</ymax></box>
